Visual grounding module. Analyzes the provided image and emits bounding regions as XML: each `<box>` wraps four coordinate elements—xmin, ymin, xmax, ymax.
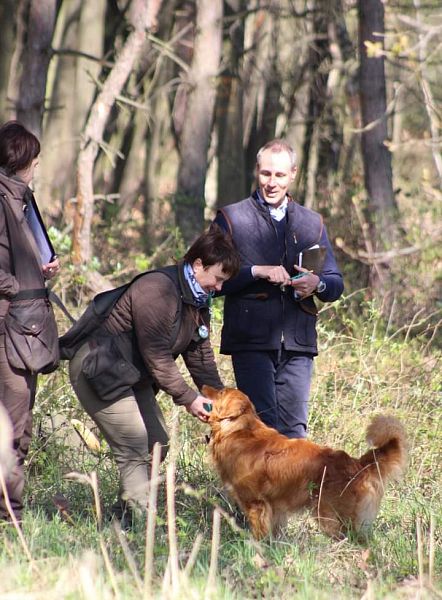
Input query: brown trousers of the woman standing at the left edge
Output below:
<box><xmin>0</xmin><ymin>335</ymin><xmax>37</xmax><ymax>520</ymax></box>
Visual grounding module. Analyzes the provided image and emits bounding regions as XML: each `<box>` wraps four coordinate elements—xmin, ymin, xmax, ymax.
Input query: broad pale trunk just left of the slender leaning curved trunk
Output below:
<box><xmin>37</xmin><ymin>0</ymin><xmax>106</xmax><ymax>216</ymax></box>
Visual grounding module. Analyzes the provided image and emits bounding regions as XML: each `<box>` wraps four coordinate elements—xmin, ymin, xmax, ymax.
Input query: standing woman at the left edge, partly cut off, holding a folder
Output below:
<box><xmin>0</xmin><ymin>121</ymin><xmax>60</xmax><ymax>520</ymax></box>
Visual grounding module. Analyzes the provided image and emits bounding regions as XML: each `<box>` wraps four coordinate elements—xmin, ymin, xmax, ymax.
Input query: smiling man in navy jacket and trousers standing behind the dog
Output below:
<box><xmin>215</xmin><ymin>139</ymin><xmax>344</xmax><ymax>438</ymax></box>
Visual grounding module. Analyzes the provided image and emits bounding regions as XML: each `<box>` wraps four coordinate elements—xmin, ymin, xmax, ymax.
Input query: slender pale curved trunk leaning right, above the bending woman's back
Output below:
<box><xmin>72</xmin><ymin>0</ymin><xmax>160</xmax><ymax>265</ymax></box>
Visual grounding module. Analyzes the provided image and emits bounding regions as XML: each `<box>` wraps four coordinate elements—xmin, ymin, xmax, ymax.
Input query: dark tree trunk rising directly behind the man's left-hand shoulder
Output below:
<box><xmin>216</xmin><ymin>0</ymin><xmax>246</xmax><ymax>207</ymax></box>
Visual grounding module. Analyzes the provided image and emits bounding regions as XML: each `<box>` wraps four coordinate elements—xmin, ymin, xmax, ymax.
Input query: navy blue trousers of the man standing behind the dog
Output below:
<box><xmin>232</xmin><ymin>347</ymin><xmax>313</xmax><ymax>438</ymax></box>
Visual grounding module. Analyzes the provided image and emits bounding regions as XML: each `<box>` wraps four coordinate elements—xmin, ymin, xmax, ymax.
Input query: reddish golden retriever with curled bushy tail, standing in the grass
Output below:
<box><xmin>202</xmin><ymin>386</ymin><xmax>407</xmax><ymax>539</ymax></box>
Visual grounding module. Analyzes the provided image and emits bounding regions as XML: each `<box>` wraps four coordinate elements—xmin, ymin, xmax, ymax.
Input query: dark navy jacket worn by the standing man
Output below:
<box><xmin>215</xmin><ymin>193</ymin><xmax>344</xmax><ymax>355</ymax></box>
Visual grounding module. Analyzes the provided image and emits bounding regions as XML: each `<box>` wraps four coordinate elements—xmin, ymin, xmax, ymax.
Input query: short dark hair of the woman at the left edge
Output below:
<box><xmin>0</xmin><ymin>121</ymin><xmax>40</xmax><ymax>175</ymax></box>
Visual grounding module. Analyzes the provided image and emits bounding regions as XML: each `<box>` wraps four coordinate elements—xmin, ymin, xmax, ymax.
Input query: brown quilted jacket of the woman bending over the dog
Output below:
<box><xmin>105</xmin><ymin>264</ymin><xmax>223</xmax><ymax>405</ymax></box>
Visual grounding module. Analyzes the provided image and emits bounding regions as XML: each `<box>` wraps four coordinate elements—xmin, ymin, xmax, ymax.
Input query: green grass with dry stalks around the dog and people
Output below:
<box><xmin>0</xmin><ymin>306</ymin><xmax>442</xmax><ymax>600</ymax></box>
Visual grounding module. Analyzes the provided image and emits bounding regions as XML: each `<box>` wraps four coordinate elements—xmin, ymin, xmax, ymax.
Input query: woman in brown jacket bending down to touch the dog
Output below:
<box><xmin>68</xmin><ymin>226</ymin><xmax>239</xmax><ymax>510</ymax></box>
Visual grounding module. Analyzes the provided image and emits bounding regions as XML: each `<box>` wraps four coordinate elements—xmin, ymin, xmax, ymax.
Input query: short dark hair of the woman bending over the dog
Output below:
<box><xmin>184</xmin><ymin>223</ymin><xmax>240</xmax><ymax>277</ymax></box>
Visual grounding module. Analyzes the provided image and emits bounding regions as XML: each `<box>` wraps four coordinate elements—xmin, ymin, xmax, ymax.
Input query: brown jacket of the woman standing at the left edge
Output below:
<box><xmin>0</xmin><ymin>169</ymin><xmax>45</xmax><ymax>333</ymax></box>
